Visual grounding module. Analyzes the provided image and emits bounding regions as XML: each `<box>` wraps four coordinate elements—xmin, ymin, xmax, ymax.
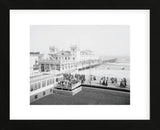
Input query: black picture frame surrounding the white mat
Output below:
<box><xmin>0</xmin><ymin>0</ymin><xmax>156</xmax><ymax>130</ymax></box>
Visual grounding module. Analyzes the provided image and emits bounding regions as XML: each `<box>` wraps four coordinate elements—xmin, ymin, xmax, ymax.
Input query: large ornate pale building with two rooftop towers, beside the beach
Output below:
<box><xmin>39</xmin><ymin>45</ymin><xmax>99</xmax><ymax>73</ymax></box>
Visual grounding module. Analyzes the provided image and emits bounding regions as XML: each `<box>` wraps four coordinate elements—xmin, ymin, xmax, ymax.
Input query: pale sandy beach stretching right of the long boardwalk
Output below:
<box><xmin>78</xmin><ymin>56</ymin><xmax>130</xmax><ymax>80</ymax></box>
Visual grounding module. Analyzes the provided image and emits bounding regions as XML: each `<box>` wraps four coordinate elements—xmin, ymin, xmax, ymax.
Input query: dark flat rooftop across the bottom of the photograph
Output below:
<box><xmin>31</xmin><ymin>87</ymin><xmax>130</xmax><ymax>105</ymax></box>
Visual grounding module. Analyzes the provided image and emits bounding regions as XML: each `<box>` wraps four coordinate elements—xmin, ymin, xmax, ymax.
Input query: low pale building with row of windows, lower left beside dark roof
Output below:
<box><xmin>30</xmin><ymin>73</ymin><xmax>63</xmax><ymax>103</ymax></box>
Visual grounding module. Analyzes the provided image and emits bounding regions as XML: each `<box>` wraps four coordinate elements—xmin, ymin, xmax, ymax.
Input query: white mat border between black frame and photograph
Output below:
<box><xmin>10</xmin><ymin>10</ymin><xmax>149</xmax><ymax>120</ymax></box>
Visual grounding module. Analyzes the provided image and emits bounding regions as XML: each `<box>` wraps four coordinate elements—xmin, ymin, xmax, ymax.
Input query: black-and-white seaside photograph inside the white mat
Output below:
<box><xmin>29</xmin><ymin>25</ymin><xmax>132</xmax><ymax>105</ymax></box>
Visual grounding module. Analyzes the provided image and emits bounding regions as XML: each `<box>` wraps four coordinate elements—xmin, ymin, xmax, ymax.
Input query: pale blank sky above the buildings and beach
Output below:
<box><xmin>30</xmin><ymin>25</ymin><xmax>130</xmax><ymax>56</ymax></box>
